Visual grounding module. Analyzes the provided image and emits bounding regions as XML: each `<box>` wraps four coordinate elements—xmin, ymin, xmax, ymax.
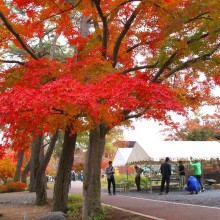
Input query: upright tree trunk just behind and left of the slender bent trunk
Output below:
<box><xmin>29</xmin><ymin>136</ymin><xmax>43</xmax><ymax>192</ymax></box>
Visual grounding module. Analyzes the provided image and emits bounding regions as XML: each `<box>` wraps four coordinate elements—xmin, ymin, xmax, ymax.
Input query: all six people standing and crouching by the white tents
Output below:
<box><xmin>105</xmin><ymin>157</ymin><xmax>205</xmax><ymax>195</ymax></box>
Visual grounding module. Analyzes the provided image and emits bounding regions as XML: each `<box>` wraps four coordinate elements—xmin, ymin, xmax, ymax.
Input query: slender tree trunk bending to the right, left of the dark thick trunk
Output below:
<box><xmin>35</xmin><ymin>130</ymin><xmax>58</xmax><ymax>205</ymax></box>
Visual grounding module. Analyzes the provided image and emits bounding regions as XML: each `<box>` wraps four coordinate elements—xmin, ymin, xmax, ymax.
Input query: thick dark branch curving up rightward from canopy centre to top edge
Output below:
<box><xmin>112</xmin><ymin>3</ymin><xmax>141</xmax><ymax>67</ymax></box>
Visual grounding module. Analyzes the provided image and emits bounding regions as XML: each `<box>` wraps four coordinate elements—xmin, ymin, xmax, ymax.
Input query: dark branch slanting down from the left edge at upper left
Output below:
<box><xmin>0</xmin><ymin>11</ymin><xmax>39</xmax><ymax>60</ymax></box>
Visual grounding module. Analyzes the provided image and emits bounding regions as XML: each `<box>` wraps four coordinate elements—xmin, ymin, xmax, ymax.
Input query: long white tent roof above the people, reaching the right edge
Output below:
<box><xmin>127</xmin><ymin>141</ymin><xmax>220</xmax><ymax>164</ymax></box>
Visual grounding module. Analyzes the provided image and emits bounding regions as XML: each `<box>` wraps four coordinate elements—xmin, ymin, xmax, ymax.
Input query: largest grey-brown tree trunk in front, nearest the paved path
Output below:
<box><xmin>83</xmin><ymin>125</ymin><xmax>109</xmax><ymax>220</ymax></box>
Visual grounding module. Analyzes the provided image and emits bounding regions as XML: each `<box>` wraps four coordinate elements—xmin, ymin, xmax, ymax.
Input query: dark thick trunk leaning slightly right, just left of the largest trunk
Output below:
<box><xmin>52</xmin><ymin>128</ymin><xmax>77</xmax><ymax>213</ymax></box>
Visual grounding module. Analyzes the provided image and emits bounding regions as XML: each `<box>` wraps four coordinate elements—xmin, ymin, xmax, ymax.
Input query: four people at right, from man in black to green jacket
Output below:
<box><xmin>160</xmin><ymin>157</ymin><xmax>205</xmax><ymax>195</ymax></box>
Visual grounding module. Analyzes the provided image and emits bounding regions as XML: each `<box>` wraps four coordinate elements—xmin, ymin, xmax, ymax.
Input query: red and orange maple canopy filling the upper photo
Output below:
<box><xmin>0</xmin><ymin>0</ymin><xmax>220</xmax><ymax>167</ymax></box>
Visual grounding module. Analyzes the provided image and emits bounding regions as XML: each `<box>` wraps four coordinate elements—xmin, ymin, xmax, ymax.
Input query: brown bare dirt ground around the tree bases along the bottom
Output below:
<box><xmin>0</xmin><ymin>195</ymin><xmax>149</xmax><ymax>220</ymax></box>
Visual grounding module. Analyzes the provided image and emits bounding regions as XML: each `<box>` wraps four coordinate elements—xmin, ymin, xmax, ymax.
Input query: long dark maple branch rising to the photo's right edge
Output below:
<box><xmin>164</xmin><ymin>43</ymin><xmax>220</xmax><ymax>79</ymax></box>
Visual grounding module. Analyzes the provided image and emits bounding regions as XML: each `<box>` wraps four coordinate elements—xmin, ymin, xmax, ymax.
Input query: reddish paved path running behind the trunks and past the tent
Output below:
<box><xmin>70</xmin><ymin>181</ymin><xmax>220</xmax><ymax>220</ymax></box>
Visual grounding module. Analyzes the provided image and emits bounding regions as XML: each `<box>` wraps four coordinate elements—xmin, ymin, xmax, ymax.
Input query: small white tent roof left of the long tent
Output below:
<box><xmin>112</xmin><ymin>148</ymin><xmax>132</xmax><ymax>167</ymax></box>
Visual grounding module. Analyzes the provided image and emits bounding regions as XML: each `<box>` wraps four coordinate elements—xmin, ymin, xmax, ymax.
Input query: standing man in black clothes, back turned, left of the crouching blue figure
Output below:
<box><xmin>160</xmin><ymin>157</ymin><xmax>171</xmax><ymax>195</ymax></box>
